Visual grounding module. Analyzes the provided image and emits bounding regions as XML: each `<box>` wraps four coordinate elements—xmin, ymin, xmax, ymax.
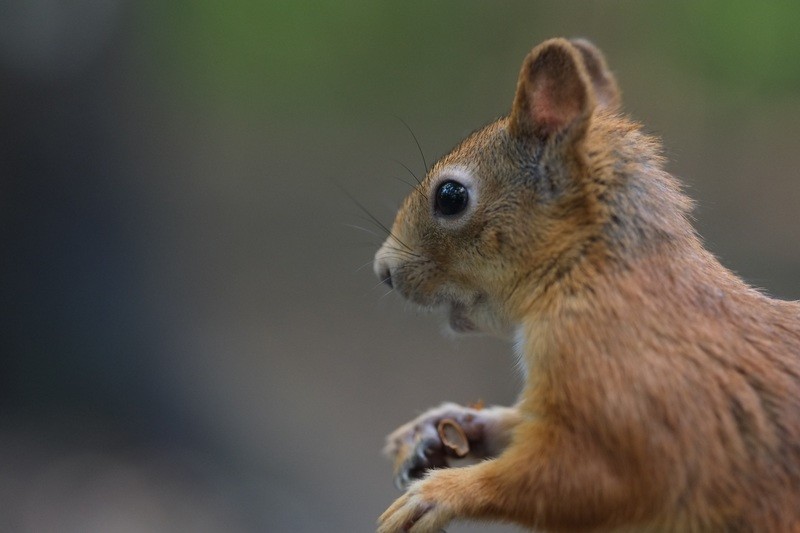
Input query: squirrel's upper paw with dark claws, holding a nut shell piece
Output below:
<box><xmin>384</xmin><ymin>403</ymin><xmax>491</xmax><ymax>490</ymax></box>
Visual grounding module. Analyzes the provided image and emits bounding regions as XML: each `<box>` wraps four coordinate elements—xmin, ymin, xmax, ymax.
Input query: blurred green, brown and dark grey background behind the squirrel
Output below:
<box><xmin>0</xmin><ymin>0</ymin><xmax>800</xmax><ymax>532</ymax></box>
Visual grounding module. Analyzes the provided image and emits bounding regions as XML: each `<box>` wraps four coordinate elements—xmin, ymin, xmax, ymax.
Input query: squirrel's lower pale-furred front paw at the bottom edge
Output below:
<box><xmin>378</xmin><ymin>480</ymin><xmax>454</xmax><ymax>533</ymax></box>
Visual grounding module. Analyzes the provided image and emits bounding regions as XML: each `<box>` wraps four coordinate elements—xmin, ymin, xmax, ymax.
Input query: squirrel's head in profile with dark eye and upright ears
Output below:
<box><xmin>374</xmin><ymin>39</ymin><xmax>688</xmax><ymax>336</ymax></box>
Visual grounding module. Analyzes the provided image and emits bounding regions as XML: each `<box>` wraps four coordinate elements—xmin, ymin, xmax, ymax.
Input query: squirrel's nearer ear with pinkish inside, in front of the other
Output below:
<box><xmin>509</xmin><ymin>39</ymin><xmax>596</xmax><ymax>140</ymax></box>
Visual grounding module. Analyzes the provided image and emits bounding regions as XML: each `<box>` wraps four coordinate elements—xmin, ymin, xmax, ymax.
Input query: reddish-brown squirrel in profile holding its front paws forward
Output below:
<box><xmin>374</xmin><ymin>38</ymin><xmax>800</xmax><ymax>533</ymax></box>
